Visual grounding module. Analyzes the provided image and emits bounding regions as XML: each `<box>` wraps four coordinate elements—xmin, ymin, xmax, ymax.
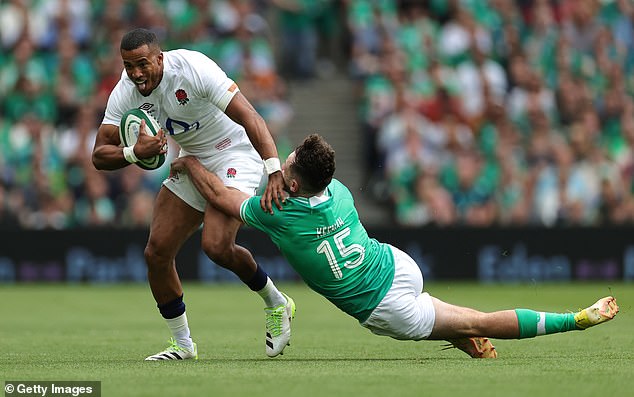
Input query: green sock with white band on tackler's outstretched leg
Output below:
<box><xmin>515</xmin><ymin>309</ymin><xmax>577</xmax><ymax>339</ymax></box>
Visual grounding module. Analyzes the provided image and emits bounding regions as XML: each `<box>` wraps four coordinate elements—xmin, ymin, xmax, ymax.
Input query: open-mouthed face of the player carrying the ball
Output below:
<box><xmin>121</xmin><ymin>44</ymin><xmax>163</xmax><ymax>96</ymax></box>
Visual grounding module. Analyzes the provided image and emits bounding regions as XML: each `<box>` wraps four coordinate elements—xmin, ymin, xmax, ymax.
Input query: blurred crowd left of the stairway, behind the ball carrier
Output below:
<box><xmin>0</xmin><ymin>0</ymin><xmax>292</xmax><ymax>229</ymax></box>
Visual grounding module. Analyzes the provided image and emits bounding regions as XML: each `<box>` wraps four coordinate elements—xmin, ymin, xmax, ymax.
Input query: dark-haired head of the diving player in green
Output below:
<box><xmin>290</xmin><ymin>134</ymin><xmax>335</xmax><ymax>193</ymax></box>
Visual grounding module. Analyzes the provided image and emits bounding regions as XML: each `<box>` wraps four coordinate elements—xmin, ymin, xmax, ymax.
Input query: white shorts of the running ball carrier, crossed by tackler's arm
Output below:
<box><xmin>163</xmin><ymin>143</ymin><xmax>264</xmax><ymax>212</ymax></box>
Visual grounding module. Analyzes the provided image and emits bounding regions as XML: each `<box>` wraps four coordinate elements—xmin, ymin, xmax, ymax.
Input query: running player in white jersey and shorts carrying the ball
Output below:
<box><xmin>92</xmin><ymin>29</ymin><xmax>295</xmax><ymax>360</ymax></box>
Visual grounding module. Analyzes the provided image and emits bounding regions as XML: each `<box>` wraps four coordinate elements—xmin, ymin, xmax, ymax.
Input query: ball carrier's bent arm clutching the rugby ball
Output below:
<box><xmin>92</xmin><ymin>120</ymin><xmax>166</xmax><ymax>170</ymax></box>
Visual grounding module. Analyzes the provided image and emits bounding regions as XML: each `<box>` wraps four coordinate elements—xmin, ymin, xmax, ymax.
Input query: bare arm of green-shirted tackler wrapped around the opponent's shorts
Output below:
<box><xmin>170</xmin><ymin>156</ymin><xmax>250</xmax><ymax>220</ymax></box>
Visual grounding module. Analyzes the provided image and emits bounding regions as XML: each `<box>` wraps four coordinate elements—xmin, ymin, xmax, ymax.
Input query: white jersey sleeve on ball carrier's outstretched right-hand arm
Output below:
<box><xmin>188</xmin><ymin>51</ymin><xmax>239</xmax><ymax>112</ymax></box>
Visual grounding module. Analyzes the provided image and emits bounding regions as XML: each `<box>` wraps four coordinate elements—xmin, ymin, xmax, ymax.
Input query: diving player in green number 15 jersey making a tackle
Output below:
<box><xmin>172</xmin><ymin>135</ymin><xmax>619</xmax><ymax>358</ymax></box>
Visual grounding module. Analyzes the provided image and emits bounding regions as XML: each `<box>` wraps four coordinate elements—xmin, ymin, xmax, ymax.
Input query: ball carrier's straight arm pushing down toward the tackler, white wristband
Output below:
<box><xmin>225</xmin><ymin>91</ymin><xmax>284</xmax><ymax>213</ymax></box>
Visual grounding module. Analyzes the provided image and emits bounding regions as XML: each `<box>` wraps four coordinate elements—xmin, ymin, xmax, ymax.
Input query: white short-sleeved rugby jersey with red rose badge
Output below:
<box><xmin>102</xmin><ymin>49</ymin><xmax>249</xmax><ymax>160</ymax></box>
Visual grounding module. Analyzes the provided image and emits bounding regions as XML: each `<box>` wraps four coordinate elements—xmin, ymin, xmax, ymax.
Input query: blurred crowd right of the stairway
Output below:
<box><xmin>354</xmin><ymin>0</ymin><xmax>634</xmax><ymax>227</ymax></box>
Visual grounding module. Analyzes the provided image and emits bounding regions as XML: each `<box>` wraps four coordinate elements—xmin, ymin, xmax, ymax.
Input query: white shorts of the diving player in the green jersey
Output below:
<box><xmin>361</xmin><ymin>247</ymin><xmax>436</xmax><ymax>340</ymax></box>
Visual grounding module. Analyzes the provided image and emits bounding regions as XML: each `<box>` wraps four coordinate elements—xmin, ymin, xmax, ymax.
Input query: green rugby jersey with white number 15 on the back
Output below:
<box><xmin>240</xmin><ymin>179</ymin><xmax>394</xmax><ymax>322</ymax></box>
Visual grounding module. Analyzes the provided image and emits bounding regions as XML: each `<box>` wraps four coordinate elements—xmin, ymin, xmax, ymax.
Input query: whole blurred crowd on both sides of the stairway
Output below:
<box><xmin>0</xmin><ymin>0</ymin><xmax>634</xmax><ymax>229</ymax></box>
